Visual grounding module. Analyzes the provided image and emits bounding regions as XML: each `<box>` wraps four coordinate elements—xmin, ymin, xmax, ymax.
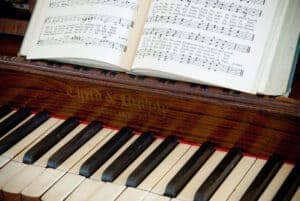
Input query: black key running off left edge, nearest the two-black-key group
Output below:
<box><xmin>0</xmin><ymin>111</ymin><xmax>49</xmax><ymax>154</ymax></box>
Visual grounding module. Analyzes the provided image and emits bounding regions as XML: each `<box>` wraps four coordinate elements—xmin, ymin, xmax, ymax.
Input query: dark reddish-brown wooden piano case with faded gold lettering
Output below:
<box><xmin>0</xmin><ymin>2</ymin><xmax>300</xmax><ymax>161</ymax></box>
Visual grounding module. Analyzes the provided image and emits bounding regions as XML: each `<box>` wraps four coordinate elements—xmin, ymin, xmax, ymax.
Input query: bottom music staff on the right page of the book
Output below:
<box><xmin>137</xmin><ymin>49</ymin><xmax>244</xmax><ymax>77</ymax></box>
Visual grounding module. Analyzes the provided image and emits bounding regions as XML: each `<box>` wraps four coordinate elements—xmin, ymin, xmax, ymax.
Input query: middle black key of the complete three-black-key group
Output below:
<box><xmin>101</xmin><ymin>132</ymin><xmax>155</xmax><ymax>182</ymax></box>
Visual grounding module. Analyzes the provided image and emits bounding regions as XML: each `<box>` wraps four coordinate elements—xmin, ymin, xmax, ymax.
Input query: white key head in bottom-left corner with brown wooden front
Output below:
<box><xmin>2</xmin><ymin>166</ymin><xmax>45</xmax><ymax>201</ymax></box>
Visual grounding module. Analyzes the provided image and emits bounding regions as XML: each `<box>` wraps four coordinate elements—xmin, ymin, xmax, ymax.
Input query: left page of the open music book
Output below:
<box><xmin>27</xmin><ymin>0</ymin><xmax>144</xmax><ymax>70</ymax></box>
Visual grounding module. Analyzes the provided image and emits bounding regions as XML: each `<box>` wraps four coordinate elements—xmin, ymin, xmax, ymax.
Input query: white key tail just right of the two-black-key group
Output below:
<box><xmin>57</xmin><ymin>128</ymin><xmax>114</xmax><ymax>171</ymax></box>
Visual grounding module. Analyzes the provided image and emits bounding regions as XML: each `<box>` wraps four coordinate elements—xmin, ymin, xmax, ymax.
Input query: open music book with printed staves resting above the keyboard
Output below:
<box><xmin>20</xmin><ymin>0</ymin><xmax>300</xmax><ymax>95</ymax></box>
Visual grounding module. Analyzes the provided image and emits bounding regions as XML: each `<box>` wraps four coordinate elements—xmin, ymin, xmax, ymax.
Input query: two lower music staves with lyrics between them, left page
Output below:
<box><xmin>37</xmin><ymin>14</ymin><xmax>133</xmax><ymax>54</ymax></box>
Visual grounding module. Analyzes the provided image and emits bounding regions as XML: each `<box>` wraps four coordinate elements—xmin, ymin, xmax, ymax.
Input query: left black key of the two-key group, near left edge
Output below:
<box><xmin>23</xmin><ymin>117</ymin><xmax>80</xmax><ymax>164</ymax></box>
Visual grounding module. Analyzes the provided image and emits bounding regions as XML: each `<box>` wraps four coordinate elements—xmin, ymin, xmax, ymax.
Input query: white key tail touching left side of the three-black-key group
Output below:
<box><xmin>68</xmin><ymin>130</ymin><xmax>118</xmax><ymax>174</ymax></box>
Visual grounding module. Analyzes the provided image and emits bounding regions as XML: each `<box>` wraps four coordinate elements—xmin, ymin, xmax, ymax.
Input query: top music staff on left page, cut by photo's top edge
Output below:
<box><xmin>49</xmin><ymin>0</ymin><xmax>138</xmax><ymax>10</ymax></box>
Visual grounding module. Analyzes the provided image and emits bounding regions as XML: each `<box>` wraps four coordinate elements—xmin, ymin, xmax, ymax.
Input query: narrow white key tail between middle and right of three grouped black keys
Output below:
<box><xmin>113</xmin><ymin>139</ymin><xmax>162</xmax><ymax>185</ymax></box>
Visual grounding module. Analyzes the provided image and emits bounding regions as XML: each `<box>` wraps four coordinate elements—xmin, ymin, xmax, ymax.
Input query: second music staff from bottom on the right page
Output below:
<box><xmin>143</xmin><ymin>28</ymin><xmax>251</xmax><ymax>53</ymax></box>
